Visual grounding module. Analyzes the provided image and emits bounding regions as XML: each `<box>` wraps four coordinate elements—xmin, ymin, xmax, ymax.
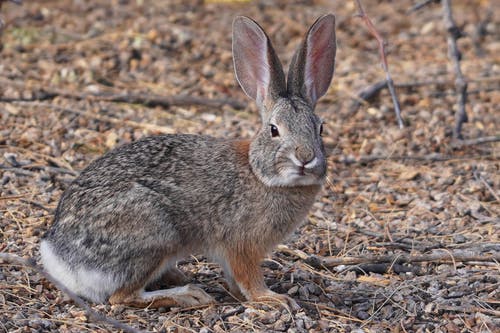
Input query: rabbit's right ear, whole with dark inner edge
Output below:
<box><xmin>287</xmin><ymin>14</ymin><xmax>337</xmax><ymax>107</ymax></box>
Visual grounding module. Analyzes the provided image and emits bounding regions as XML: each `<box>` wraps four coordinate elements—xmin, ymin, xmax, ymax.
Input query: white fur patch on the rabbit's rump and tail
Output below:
<box><xmin>40</xmin><ymin>240</ymin><xmax>120</xmax><ymax>303</ymax></box>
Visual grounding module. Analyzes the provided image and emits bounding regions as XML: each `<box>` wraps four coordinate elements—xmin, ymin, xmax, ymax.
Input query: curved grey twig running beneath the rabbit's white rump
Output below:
<box><xmin>0</xmin><ymin>253</ymin><xmax>145</xmax><ymax>333</ymax></box>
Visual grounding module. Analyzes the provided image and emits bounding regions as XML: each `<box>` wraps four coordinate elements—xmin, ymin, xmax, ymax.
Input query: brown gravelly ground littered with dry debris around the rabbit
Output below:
<box><xmin>0</xmin><ymin>0</ymin><xmax>500</xmax><ymax>332</ymax></box>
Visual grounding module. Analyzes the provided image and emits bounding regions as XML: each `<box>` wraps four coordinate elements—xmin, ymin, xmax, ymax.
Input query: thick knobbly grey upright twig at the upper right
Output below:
<box><xmin>441</xmin><ymin>0</ymin><xmax>468</xmax><ymax>139</ymax></box>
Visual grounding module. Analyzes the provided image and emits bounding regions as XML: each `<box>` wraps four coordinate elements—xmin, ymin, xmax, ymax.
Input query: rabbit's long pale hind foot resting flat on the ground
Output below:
<box><xmin>109</xmin><ymin>284</ymin><xmax>214</xmax><ymax>308</ymax></box>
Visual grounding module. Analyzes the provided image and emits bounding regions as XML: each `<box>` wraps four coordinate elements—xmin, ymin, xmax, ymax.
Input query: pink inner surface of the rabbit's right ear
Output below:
<box><xmin>304</xmin><ymin>20</ymin><xmax>335</xmax><ymax>103</ymax></box>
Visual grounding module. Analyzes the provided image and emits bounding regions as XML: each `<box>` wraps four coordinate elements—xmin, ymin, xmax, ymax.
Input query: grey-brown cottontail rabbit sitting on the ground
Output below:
<box><xmin>40</xmin><ymin>14</ymin><xmax>336</xmax><ymax>308</ymax></box>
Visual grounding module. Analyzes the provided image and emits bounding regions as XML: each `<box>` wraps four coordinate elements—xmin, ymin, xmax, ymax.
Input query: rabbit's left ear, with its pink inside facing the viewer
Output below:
<box><xmin>233</xmin><ymin>16</ymin><xmax>286</xmax><ymax>109</ymax></box>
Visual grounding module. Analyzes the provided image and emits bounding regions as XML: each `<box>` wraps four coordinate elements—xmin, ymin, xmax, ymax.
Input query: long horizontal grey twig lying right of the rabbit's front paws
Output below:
<box><xmin>306</xmin><ymin>250</ymin><xmax>500</xmax><ymax>267</ymax></box>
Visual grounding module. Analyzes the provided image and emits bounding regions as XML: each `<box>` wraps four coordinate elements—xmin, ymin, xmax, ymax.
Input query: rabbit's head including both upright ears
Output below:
<box><xmin>233</xmin><ymin>14</ymin><xmax>336</xmax><ymax>186</ymax></box>
